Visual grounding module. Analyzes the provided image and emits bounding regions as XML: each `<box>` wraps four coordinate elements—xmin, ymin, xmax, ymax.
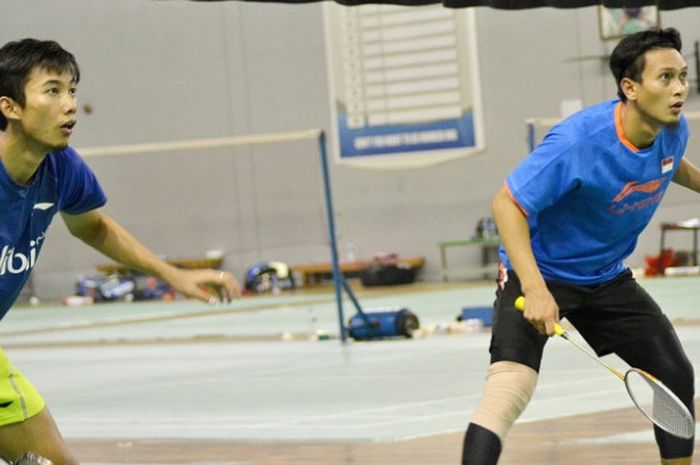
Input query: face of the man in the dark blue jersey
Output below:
<box><xmin>19</xmin><ymin>68</ymin><xmax>77</xmax><ymax>150</ymax></box>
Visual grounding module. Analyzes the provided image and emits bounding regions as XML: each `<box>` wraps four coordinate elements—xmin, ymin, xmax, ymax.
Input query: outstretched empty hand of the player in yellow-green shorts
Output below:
<box><xmin>166</xmin><ymin>269</ymin><xmax>241</xmax><ymax>304</ymax></box>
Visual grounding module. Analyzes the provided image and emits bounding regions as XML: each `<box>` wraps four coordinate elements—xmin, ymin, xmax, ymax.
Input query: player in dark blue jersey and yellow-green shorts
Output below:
<box><xmin>0</xmin><ymin>39</ymin><xmax>240</xmax><ymax>465</ymax></box>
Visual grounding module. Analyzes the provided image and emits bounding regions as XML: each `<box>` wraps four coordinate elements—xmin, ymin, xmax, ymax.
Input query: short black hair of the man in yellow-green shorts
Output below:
<box><xmin>0</xmin><ymin>39</ymin><xmax>80</xmax><ymax>131</ymax></box>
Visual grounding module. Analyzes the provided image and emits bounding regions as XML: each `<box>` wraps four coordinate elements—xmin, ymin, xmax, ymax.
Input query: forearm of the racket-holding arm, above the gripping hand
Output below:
<box><xmin>492</xmin><ymin>188</ymin><xmax>546</xmax><ymax>295</ymax></box>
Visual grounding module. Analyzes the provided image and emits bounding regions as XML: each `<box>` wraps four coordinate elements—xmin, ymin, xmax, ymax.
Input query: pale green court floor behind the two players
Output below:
<box><xmin>0</xmin><ymin>278</ymin><xmax>700</xmax><ymax>456</ymax></box>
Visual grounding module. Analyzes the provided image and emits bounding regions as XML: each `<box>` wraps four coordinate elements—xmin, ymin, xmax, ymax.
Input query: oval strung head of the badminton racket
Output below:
<box><xmin>625</xmin><ymin>368</ymin><xmax>695</xmax><ymax>439</ymax></box>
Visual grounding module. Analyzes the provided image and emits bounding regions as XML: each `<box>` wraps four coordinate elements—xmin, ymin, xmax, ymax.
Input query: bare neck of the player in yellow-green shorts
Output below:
<box><xmin>0</xmin><ymin>127</ymin><xmax>47</xmax><ymax>185</ymax></box>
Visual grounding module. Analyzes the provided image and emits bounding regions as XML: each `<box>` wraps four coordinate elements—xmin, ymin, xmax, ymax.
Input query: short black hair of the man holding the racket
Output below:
<box><xmin>610</xmin><ymin>27</ymin><xmax>683</xmax><ymax>102</ymax></box>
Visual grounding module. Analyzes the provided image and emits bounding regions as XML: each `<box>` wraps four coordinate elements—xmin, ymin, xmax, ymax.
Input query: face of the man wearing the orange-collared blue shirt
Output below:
<box><xmin>634</xmin><ymin>48</ymin><xmax>688</xmax><ymax>125</ymax></box>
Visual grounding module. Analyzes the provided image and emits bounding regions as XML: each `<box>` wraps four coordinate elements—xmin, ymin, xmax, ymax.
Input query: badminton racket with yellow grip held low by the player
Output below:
<box><xmin>514</xmin><ymin>296</ymin><xmax>695</xmax><ymax>439</ymax></box>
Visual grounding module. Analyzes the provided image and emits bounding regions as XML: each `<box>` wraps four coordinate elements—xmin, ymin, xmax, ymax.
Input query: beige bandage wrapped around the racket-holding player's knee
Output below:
<box><xmin>472</xmin><ymin>361</ymin><xmax>537</xmax><ymax>442</ymax></box>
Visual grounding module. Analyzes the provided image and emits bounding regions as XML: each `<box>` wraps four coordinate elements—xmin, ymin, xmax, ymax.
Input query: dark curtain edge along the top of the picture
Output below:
<box><xmin>182</xmin><ymin>0</ymin><xmax>700</xmax><ymax>10</ymax></box>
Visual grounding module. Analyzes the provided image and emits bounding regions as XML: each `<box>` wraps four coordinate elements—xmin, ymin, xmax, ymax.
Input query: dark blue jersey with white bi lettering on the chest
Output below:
<box><xmin>0</xmin><ymin>148</ymin><xmax>107</xmax><ymax>318</ymax></box>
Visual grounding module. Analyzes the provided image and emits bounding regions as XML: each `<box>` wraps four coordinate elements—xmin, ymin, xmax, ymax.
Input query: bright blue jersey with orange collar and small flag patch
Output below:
<box><xmin>501</xmin><ymin>100</ymin><xmax>688</xmax><ymax>285</ymax></box>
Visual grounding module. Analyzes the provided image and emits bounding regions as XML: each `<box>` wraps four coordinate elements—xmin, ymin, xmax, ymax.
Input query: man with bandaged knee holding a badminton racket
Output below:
<box><xmin>462</xmin><ymin>28</ymin><xmax>700</xmax><ymax>465</ymax></box>
